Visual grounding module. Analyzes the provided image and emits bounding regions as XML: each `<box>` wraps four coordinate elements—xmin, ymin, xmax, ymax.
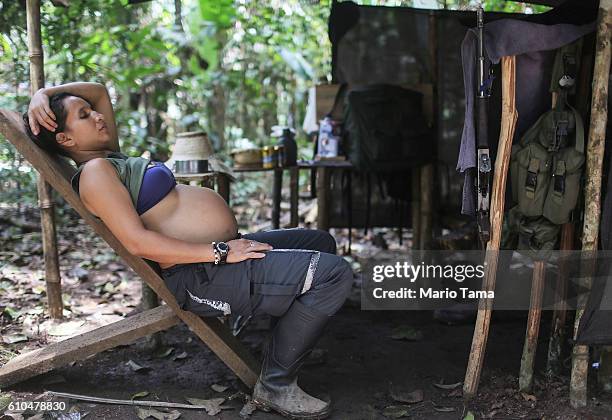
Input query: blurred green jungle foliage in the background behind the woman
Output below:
<box><xmin>0</xmin><ymin>0</ymin><xmax>542</xmax><ymax>205</ymax></box>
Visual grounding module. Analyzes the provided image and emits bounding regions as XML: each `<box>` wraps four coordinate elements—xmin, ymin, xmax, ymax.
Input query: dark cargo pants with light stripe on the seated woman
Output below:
<box><xmin>162</xmin><ymin>229</ymin><xmax>353</xmax><ymax>316</ymax></box>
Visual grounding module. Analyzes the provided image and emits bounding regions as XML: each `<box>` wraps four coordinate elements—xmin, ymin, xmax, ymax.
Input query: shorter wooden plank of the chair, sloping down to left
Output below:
<box><xmin>0</xmin><ymin>305</ymin><xmax>179</xmax><ymax>386</ymax></box>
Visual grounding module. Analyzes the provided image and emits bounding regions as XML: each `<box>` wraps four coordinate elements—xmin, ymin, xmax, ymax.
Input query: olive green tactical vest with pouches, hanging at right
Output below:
<box><xmin>502</xmin><ymin>40</ymin><xmax>585</xmax><ymax>260</ymax></box>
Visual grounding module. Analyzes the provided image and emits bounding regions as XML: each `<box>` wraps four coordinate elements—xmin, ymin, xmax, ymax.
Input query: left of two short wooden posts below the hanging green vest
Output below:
<box><xmin>519</xmin><ymin>261</ymin><xmax>546</xmax><ymax>393</ymax></box>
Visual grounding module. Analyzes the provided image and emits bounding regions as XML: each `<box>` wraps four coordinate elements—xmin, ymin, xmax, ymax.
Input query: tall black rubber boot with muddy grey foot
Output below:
<box><xmin>253</xmin><ymin>300</ymin><xmax>330</xmax><ymax>419</ymax></box>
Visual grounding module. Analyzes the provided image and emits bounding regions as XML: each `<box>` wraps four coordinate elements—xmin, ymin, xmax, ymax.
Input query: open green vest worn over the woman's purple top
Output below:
<box><xmin>70</xmin><ymin>152</ymin><xmax>150</xmax><ymax>208</ymax></box>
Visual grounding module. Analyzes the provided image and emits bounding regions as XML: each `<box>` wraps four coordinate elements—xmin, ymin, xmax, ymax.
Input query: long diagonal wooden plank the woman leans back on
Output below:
<box><xmin>0</xmin><ymin>109</ymin><xmax>259</xmax><ymax>387</ymax></box>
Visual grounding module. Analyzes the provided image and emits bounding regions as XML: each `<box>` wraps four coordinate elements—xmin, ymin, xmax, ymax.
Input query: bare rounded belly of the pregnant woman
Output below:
<box><xmin>140</xmin><ymin>184</ymin><xmax>238</xmax><ymax>268</ymax></box>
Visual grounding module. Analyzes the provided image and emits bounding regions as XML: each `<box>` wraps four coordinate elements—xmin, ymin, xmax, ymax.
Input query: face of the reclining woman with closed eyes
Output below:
<box><xmin>56</xmin><ymin>96</ymin><xmax>111</xmax><ymax>152</ymax></box>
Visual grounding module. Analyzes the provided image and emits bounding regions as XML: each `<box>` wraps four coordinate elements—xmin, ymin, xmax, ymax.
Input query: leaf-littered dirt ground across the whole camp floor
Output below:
<box><xmin>0</xmin><ymin>203</ymin><xmax>612</xmax><ymax>420</ymax></box>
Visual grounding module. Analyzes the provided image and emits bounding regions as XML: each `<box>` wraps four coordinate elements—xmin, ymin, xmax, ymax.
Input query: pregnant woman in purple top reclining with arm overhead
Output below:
<box><xmin>24</xmin><ymin>82</ymin><xmax>353</xmax><ymax>419</ymax></box>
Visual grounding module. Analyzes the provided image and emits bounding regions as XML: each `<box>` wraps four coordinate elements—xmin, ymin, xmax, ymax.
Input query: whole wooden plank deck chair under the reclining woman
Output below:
<box><xmin>0</xmin><ymin>109</ymin><xmax>260</xmax><ymax>387</ymax></box>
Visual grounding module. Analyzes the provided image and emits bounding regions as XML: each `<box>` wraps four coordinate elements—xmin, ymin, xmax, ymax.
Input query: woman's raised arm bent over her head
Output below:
<box><xmin>28</xmin><ymin>82</ymin><xmax>119</xmax><ymax>152</ymax></box>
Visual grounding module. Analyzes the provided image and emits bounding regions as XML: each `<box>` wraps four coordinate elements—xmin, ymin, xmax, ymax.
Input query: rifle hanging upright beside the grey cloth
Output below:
<box><xmin>476</xmin><ymin>7</ymin><xmax>493</xmax><ymax>247</ymax></box>
